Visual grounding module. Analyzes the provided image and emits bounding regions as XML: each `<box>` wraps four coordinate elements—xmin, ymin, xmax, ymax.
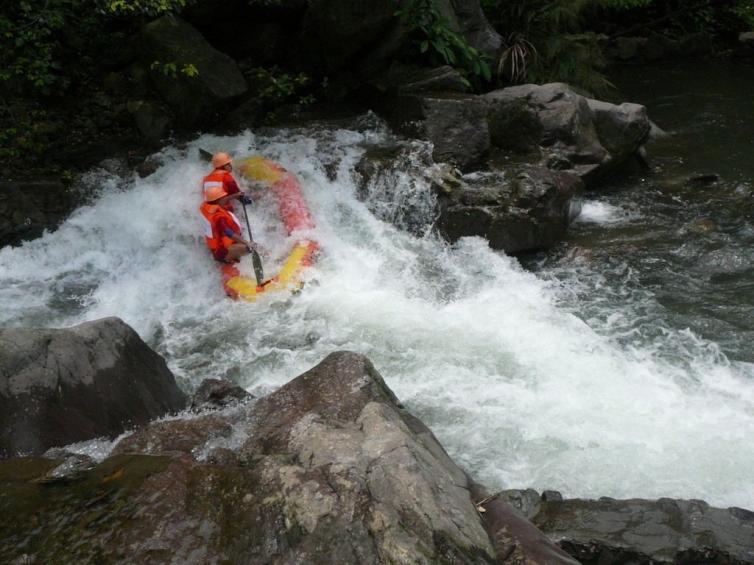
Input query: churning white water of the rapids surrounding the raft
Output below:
<box><xmin>0</xmin><ymin>121</ymin><xmax>754</xmax><ymax>508</ymax></box>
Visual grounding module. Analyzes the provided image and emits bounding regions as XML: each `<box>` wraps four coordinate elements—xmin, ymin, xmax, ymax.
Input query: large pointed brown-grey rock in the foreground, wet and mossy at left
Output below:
<box><xmin>0</xmin><ymin>352</ymin><xmax>496</xmax><ymax>564</ymax></box>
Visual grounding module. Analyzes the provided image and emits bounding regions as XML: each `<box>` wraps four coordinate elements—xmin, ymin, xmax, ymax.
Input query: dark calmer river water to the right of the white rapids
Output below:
<box><xmin>531</xmin><ymin>61</ymin><xmax>754</xmax><ymax>362</ymax></box>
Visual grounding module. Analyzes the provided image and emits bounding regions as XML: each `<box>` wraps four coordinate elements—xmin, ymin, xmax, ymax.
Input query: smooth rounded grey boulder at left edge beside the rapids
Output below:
<box><xmin>0</xmin><ymin>318</ymin><xmax>185</xmax><ymax>457</ymax></box>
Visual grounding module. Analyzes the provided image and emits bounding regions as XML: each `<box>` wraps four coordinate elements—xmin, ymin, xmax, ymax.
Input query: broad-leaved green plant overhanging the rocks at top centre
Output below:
<box><xmin>395</xmin><ymin>0</ymin><xmax>492</xmax><ymax>86</ymax></box>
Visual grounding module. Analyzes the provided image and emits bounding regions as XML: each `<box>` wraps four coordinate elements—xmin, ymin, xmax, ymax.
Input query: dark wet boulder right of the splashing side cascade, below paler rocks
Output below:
<box><xmin>437</xmin><ymin>163</ymin><xmax>583</xmax><ymax>253</ymax></box>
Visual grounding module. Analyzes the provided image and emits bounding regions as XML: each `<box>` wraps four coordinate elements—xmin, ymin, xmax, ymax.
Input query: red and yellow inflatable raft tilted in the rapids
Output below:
<box><xmin>220</xmin><ymin>155</ymin><xmax>318</xmax><ymax>301</ymax></box>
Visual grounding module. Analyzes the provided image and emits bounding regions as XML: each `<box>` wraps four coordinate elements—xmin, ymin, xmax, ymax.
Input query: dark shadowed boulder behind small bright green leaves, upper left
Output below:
<box><xmin>142</xmin><ymin>15</ymin><xmax>247</xmax><ymax>126</ymax></box>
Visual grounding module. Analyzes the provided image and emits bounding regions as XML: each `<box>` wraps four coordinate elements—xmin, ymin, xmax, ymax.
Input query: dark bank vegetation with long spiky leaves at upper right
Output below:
<box><xmin>482</xmin><ymin>0</ymin><xmax>754</xmax><ymax>93</ymax></box>
